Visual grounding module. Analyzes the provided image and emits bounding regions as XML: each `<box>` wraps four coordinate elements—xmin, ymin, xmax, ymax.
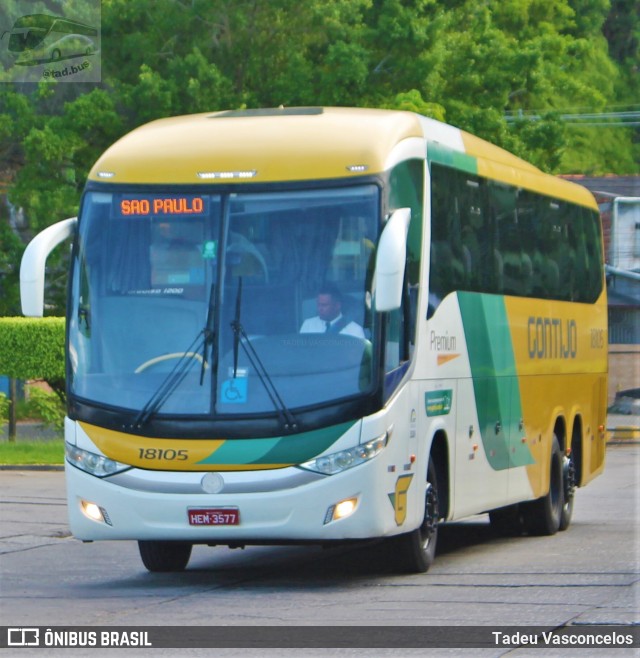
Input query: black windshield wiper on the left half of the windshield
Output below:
<box><xmin>133</xmin><ymin>284</ymin><xmax>215</xmax><ymax>429</ymax></box>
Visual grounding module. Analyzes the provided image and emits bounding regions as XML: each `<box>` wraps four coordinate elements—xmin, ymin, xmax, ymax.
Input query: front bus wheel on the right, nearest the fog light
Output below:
<box><xmin>392</xmin><ymin>458</ymin><xmax>440</xmax><ymax>573</ymax></box>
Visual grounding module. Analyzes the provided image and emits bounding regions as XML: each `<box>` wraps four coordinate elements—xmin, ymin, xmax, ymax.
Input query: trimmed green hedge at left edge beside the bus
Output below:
<box><xmin>0</xmin><ymin>318</ymin><xmax>65</xmax><ymax>385</ymax></box>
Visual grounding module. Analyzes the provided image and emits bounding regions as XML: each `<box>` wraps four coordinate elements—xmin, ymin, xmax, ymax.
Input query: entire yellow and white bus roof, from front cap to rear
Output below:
<box><xmin>89</xmin><ymin>107</ymin><xmax>597</xmax><ymax>207</ymax></box>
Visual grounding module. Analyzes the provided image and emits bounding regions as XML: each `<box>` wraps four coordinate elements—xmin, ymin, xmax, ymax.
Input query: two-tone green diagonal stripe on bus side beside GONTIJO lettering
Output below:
<box><xmin>458</xmin><ymin>292</ymin><xmax>534</xmax><ymax>470</ymax></box>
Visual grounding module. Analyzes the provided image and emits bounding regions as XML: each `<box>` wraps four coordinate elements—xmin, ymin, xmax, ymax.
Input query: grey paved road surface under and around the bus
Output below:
<box><xmin>0</xmin><ymin>445</ymin><xmax>640</xmax><ymax>658</ymax></box>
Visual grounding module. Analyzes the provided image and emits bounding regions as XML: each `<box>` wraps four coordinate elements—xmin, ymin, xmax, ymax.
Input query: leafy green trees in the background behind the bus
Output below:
<box><xmin>0</xmin><ymin>0</ymin><xmax>640</xmax><ymax>314</ymax></box>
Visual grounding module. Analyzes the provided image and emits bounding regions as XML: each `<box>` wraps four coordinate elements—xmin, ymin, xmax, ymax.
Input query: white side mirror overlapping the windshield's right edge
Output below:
<box><xmin>374</xmin><ymin>208</ymin><xmax>411</xmax><ymax>312</ymax></box>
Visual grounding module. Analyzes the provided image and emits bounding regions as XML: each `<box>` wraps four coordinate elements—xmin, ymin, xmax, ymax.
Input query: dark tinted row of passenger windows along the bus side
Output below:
<box><xmin>427</xmin><ymin>163</ymin><xmax>602</xmax><ymax>304</ymax></box>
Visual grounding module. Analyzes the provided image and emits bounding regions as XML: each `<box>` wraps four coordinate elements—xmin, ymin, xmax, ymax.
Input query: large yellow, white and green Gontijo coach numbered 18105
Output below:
<box><xmin>20</xmin><ymin>107</ymin><xmax>607</xmax><ymax>573</ymax></box>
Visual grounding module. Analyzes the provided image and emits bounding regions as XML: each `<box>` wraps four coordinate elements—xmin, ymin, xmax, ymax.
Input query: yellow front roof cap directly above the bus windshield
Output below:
<box><xmin>90</xmin><ymin>108</ymin><xmax>422</xmax><ymax>183</ymax></box>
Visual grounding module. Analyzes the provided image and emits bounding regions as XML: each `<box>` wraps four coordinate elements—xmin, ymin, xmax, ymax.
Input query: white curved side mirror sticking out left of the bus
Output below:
<box><xmin>20</xmin><ymin>217</ymin><xmax>78</xmax><ymax>318</ymax></box>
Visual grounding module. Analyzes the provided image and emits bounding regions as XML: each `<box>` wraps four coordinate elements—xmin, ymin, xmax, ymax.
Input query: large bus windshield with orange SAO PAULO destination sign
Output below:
<box><xmin>69</xmin><ymin>185</ymin><xmax>380</xmax><ymax>420</ymax></box>
